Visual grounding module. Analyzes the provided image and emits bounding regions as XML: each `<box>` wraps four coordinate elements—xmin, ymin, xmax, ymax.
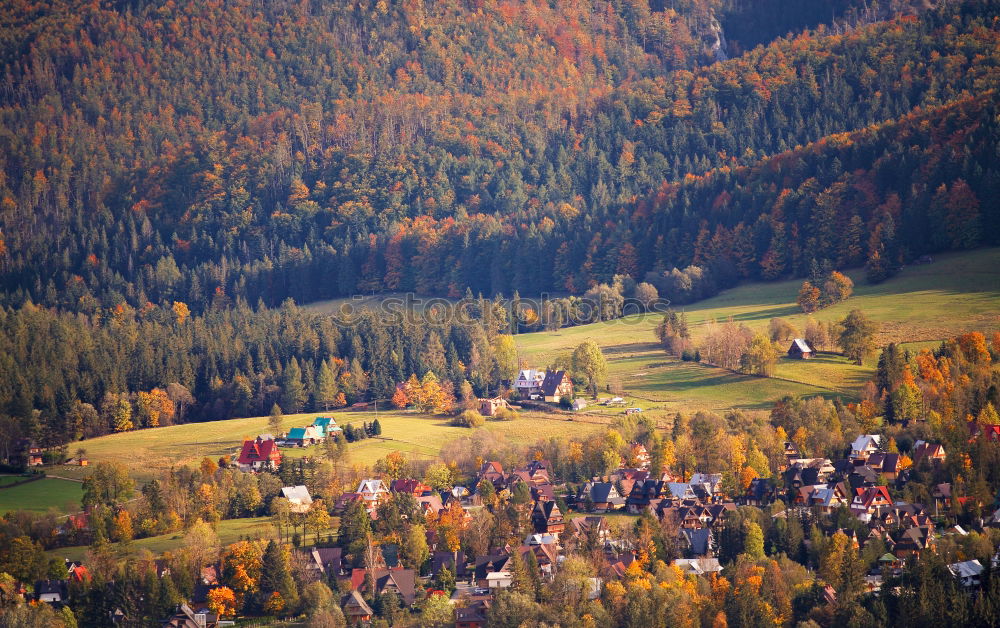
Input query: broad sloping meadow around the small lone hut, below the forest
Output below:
<box><xmin>517</xmin><ymin>249</ymin><xmax>1000</xmax><ymax>410</ymax></box>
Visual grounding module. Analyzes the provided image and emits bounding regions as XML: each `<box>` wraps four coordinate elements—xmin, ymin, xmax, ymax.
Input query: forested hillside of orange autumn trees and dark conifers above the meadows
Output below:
<box><xmin>0</xmin><ymin>0</ymin><xmax>1000</xmax><ymax>313</ymax></box>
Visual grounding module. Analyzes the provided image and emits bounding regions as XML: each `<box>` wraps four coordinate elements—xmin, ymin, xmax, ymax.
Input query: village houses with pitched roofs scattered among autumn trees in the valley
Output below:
<box><xmin>36</xmin><ymin>424</ymin><xmax>1000</xmax><ymax>628</ymax></box>
